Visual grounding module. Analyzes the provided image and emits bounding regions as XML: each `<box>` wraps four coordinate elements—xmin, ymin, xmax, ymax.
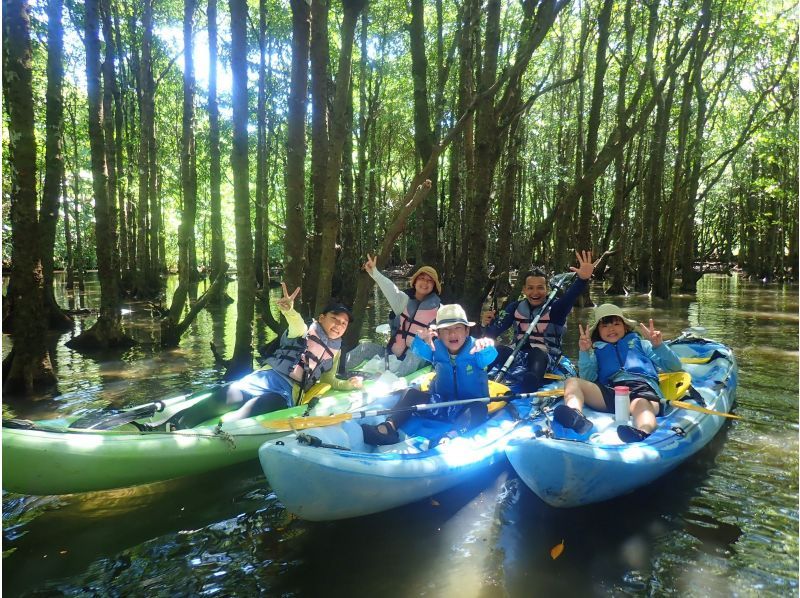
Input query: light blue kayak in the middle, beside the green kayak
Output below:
<box><xmin>258</xmin><ymin>386</ymin><xmax>552</xmax><ymax>521</ymax></box>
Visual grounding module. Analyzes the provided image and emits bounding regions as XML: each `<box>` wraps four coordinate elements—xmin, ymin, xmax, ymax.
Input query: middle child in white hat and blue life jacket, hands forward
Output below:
<box><xmin>361</xmin><ymin>305</ymin><xmax>497</xmax><ymax>445</ymax></box>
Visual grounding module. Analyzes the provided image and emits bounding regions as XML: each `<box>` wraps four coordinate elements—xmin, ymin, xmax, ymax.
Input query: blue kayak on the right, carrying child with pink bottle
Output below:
<box><xmin>506</xmin><ymin>338</ymin><xmax>737</xmax><ymax>507</ymax></box>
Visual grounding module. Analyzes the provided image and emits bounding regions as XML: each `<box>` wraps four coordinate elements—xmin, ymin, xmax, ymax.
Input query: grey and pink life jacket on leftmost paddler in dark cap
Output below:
<box><xmin>267</xmin><ymin>320</ymin><xmax>342</xmax><ymax>392</ymax></box>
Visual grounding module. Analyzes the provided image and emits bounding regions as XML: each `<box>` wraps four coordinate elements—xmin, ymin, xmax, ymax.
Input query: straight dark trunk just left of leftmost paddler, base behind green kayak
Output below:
<box><xmin>225</xmin><ymin>0</ymin><xmax>255</xmax><ymax>380</ymax></box>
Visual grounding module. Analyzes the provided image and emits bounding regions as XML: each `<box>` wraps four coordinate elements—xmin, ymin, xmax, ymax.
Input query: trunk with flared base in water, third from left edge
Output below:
<box><xmin>67</xmin><ymin>0</ymin><xmax>133</xmax><ymax>351</ymax></box>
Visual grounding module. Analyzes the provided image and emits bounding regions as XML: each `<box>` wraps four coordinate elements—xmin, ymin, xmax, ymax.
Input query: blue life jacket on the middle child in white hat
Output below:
<box><xmin>430</xmin><ymin>336</ymin><xmax>489</xmax><ymax>401</ymax></box>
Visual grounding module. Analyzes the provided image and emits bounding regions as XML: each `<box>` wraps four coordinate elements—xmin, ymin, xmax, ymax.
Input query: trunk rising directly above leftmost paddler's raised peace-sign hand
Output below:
<box><xmin>283</xmin><ymin>0</ymin><xmax>311</xmax><ymax>292</ymax></box>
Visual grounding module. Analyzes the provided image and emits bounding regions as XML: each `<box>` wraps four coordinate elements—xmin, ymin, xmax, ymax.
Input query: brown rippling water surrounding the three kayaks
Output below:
<box><xmin>3</xmin><ymin>276</ymin><xmax>798</xmax><ymax>598</ymax></box>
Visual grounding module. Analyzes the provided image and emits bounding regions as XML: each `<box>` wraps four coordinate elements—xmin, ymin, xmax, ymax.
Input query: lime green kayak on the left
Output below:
<box><xmin>3</xmin><ymin>373</ymin><xmax>424</xmax><ymax>495</ymax></box>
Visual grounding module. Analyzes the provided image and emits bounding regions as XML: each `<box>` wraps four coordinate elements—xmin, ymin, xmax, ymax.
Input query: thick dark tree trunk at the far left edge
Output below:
<box><xmin>3</xmin><ymin>0</ymin><xmax>56</xmax><ymax>394</ymax></box>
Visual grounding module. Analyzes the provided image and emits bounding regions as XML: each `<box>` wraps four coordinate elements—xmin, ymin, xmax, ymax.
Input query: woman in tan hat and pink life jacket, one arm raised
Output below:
<box><xmin>364</xmin><ymin>254</ymin><xmax>442</xmax><ymax>376</ymax></box>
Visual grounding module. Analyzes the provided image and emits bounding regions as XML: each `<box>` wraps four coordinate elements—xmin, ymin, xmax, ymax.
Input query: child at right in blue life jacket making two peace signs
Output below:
<box><xmin>553</xmin><ymin>303</ymin><xmax>683</xmax><ymax>442</ymax></box>
